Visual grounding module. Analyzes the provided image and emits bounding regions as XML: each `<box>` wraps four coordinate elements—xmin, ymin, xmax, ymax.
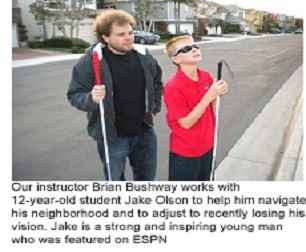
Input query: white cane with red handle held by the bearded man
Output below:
<box><xmin>92</xmin><ymin>52</ymin><xmax>112</xmax><ymax>181</ymax></box>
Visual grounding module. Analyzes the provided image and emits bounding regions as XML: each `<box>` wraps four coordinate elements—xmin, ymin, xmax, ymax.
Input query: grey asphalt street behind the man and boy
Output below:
<box><xmin>12</xmin><ymin>35</ymin><xmax>303</xmax><ymax>181</ymax></box>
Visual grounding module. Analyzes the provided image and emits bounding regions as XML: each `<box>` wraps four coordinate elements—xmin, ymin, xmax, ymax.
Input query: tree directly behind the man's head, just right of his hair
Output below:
<box><xmin>133</xmin><ymin>0</ymin><xmax>163</xmax><ymax>31</ymax></box>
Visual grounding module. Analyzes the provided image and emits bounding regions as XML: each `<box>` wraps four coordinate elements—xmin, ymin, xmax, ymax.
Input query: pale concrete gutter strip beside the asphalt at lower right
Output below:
<box><xmin>216</xmin><ymin>65</ymin><xmax>303</xmax><ymax>181</ymax></box>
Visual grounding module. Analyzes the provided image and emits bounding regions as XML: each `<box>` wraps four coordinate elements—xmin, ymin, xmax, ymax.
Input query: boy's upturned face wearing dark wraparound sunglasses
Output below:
<box><xmin>172</xmin><ymin>40</ymin><xmax>202</xmax><ymax>65</ymax></box>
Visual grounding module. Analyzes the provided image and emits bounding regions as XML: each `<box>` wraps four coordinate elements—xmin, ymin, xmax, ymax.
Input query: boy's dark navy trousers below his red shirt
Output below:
<box><xmin>169</xmin><ymin>149</ymin><xmax>213</xmax><ymax>181</ymax></box>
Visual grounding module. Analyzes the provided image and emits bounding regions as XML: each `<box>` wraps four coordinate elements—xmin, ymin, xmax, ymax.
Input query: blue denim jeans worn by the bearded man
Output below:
<box><xmin>97</xmin><ymin>127</ymin><xmax>157</xmax><ymax>181</ymax></box>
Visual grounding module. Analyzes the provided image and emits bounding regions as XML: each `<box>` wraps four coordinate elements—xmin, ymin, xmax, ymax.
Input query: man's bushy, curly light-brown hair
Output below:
<box><xmin>93</xmin><ymin>9</ymin><xmax>136</xmax><ymax>44</ymax></box>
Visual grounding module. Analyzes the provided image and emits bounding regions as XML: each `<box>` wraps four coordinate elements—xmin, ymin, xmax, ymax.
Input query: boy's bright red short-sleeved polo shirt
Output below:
<box><xmin>164</xmin><ymin>69</ymin><xmax>215</xmax><ymax>157</ymax></box>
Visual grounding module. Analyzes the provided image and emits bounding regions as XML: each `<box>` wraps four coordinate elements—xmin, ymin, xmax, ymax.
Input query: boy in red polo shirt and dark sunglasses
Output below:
<box><xmin>164</xmin><ymin>36</ymin><xmax>228</xmax><ymax>181</ymax></box>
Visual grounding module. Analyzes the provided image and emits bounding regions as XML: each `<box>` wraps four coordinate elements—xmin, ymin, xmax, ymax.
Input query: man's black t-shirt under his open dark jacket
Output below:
<box><xmin>103</xmin><ymin>46</ymin><xmax>145</xmax><ymax>137</ymax></box>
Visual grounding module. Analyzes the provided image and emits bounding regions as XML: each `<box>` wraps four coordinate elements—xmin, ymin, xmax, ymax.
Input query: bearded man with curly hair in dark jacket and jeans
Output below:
<box><xmin>67</xmin><ymin>10</ymin><xmax>163</xmax><ymax>181</ymax></box>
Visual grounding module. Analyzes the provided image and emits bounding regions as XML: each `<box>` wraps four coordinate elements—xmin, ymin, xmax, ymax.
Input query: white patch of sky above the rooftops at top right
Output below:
<box><xmin>211</xmin><ymin>0</ymin><xmax>305</xmax><ymax>18</ymax></box>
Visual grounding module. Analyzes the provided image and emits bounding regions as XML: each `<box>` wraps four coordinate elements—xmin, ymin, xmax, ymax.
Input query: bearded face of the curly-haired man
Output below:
<box><xmin>102</xmin><ymin>23</ymin><xmax>134</xmax><ymax>54</ymax></box>
